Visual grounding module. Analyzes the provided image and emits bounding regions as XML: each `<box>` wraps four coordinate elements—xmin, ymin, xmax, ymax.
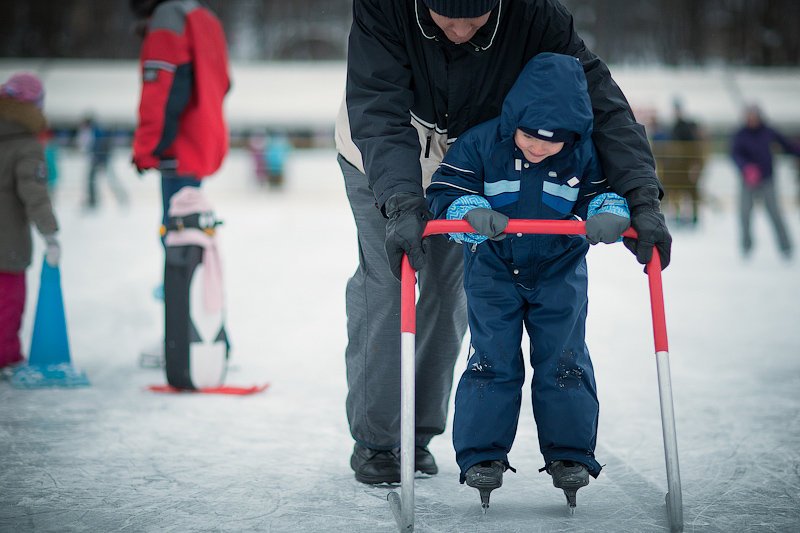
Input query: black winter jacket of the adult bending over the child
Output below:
<box><xmin>346</xmin><ymin>0</ymin><xmax>661</xmax><ymax>206</ymax></box>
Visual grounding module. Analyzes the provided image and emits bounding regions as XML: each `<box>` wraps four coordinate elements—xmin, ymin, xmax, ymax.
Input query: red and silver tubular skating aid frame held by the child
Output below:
<box><xmin>387</xmin><ymin>219</ymin><xmax>683</xmax><ymax>531</ymax></box>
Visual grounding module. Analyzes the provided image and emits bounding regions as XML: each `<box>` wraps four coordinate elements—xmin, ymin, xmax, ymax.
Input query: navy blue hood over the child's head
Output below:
<box><xmin>500</xmin><ymin>53</ymin><xmax>594</xmax><ymax>143</ymax></box>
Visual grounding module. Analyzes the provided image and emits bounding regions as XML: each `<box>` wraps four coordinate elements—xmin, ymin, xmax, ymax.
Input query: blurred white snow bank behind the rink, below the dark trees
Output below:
<box><xmin>0</xmin><ymin>58</ymin><xmax>800</xmax><ymax>131</ymax></box>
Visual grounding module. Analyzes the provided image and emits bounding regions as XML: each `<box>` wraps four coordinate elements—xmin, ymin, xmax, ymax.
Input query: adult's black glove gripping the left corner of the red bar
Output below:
<box><xmin>384</xmin><ymin>193</ymin><xmax>433</xmax><ymax>279</ymax></box>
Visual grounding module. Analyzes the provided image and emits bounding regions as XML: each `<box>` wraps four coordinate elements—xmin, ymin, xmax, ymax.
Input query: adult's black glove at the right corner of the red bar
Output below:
<box><xmin>622</xmin><ymin>187</ymin><xmax>672</xmax><ymax>270</ymax></box>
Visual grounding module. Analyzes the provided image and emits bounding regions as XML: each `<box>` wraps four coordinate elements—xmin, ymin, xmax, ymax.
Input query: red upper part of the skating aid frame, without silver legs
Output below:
<box><xmin>400</xmin><ymin>219</ymin><xmax>669</xmax><ymax>353</ymax></box>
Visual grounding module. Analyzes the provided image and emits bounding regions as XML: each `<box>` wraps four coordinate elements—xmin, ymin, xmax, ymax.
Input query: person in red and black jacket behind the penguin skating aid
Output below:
<box><xmin>130</xmin><ymin>0</ymin><xmax>230</xmax><ymax>231</ymax></box>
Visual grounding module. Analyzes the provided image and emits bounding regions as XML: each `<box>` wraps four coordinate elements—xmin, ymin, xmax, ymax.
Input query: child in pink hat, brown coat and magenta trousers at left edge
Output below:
<box><xmin>0</xmin><ymin>72</ymin><xmax>61</xmax><ymax>368</ymax></box>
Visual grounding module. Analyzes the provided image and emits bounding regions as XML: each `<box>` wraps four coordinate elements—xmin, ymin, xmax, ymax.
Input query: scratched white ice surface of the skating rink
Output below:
<box><xmin>0</xmin><ymin>150</ymin><xmax>800</xmax><ymax>533</ymax></box>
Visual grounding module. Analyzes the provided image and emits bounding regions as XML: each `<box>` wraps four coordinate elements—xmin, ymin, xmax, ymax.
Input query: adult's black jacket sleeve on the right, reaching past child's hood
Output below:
<box><xmin>534</xmin><ymin>0</ymin><xmax>663</xmax><ymax>196</ymax></box>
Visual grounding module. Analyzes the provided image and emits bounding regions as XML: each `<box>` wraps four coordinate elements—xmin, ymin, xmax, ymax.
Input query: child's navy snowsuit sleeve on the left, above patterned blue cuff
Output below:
<box><xmin>426</xmin><ymin>131</ymin><xmax>483</xmax><ymax>218</ymax></box>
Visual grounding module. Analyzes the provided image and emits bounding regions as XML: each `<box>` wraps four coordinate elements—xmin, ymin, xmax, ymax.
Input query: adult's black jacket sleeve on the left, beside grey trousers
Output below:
<box><xmin>346</xmin><ymin>0</ymin><xmax>422</xmax><ymax>206</ymax></box>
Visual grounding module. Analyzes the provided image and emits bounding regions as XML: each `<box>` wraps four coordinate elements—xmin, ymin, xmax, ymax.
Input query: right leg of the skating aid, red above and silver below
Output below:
<box><xmin>647</xmin><ymin>254</ymin><xmax>683</xmax><ymax>531</ymax></box>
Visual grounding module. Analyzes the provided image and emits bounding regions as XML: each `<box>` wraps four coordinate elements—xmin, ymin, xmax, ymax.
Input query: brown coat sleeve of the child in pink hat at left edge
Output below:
<box><xmin>14</xmin><ymin>141</ymin><xmax>58</xmax><ymax>239</ymax></box>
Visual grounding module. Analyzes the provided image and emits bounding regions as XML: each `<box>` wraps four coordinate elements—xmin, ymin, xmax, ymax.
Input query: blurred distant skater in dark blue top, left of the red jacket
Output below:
<box><xmin>77</xmin><ymin>115</ymin><xmax>128</xmax><ymax>210</ymax></box>
